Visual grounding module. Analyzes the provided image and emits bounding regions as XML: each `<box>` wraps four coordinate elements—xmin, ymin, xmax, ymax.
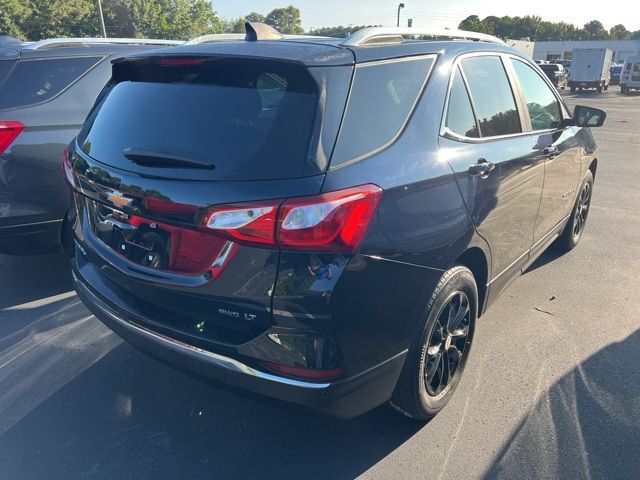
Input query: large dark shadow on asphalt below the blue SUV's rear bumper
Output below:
<box><xmin>0</xmin><ymin>344</ymin><xmax>424</xmax><ymax>479</ymax></box>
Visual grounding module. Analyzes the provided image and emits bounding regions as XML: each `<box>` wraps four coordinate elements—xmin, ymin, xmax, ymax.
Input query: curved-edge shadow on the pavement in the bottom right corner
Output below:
<box><xmin>485</xmin><ymin>325</ymin><xmax>640</xmax><ymax>480</ymax></box>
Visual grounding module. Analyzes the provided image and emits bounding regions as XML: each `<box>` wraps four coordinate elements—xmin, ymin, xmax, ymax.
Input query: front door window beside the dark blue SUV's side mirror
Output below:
<box><xmin>511</xmin><ymin>60</ymin><xmax>562</xmax><ymax>131</ymax></box>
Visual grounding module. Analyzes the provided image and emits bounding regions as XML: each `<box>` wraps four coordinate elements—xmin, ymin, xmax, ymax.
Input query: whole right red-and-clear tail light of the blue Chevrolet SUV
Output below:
<box><xmin>204</xmin><ymin>185</ymin><xmax>382</xmax><ymax>252</ymax></box>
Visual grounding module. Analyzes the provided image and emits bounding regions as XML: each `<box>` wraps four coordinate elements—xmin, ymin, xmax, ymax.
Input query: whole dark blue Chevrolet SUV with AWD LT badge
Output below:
<box><xmin>63</xmin><ymin>24</ymin><xmax>605</xmax><ymax>420</ymax></box>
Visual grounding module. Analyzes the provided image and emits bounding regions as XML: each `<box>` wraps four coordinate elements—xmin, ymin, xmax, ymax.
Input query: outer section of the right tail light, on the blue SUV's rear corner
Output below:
<box><xmin>278</xmin><ymin>185</ymin><xmax>382</xmax><ymax>252</ymax></box>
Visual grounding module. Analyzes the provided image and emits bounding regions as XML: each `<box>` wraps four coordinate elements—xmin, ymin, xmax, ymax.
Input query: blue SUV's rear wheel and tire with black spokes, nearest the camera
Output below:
<box><xmin>389</xmin><ymin>265</ymin><xmax>478</xmax><ymax>421</ymax></box>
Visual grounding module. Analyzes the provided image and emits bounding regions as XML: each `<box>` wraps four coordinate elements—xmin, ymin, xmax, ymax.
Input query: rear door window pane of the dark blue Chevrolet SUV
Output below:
<box><xmin>461</xmin><ymin>56</ymin><xmax>522</xmax><ymax>137</ymax></box>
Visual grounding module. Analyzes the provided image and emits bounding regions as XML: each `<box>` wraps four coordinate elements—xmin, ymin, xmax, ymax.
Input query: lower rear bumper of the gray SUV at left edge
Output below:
<box><xmin>0</xmin><ymin>219</ymin><xmax>62</xmax><ymax>255</ymax></box>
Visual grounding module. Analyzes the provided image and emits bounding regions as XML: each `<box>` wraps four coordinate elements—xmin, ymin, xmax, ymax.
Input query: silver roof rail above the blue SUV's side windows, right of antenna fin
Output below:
<box><xmin>342</xmin><ymin>27</ymin><xmax>506</xmax><ymax>47</ymax></box>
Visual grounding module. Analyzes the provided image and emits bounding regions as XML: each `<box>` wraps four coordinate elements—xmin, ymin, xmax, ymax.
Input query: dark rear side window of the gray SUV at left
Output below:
<box><xmin>0</xmin><ymin>57</ymin><xmax>102</xmax><ymax>108</ymax></box>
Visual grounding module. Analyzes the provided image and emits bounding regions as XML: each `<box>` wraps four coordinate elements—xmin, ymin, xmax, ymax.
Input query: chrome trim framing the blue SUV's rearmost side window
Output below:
<box><xmin>328</xmin><ymin>53</ymin><xmax>438</xmax><ymax>171</ymax></box>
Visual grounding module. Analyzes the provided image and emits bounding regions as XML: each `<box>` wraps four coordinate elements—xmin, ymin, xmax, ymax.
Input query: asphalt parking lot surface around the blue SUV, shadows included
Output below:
<box><xmin>0</xmin><ymin>87</ymin><xmax>640</xmax><ymax>479</ymax></box>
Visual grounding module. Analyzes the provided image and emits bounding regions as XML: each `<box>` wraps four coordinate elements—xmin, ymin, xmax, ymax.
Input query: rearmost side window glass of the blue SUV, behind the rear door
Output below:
<box><xmin>331</xmin><ymin>57</ymin><xmax>433</xmax><ymax>166</ymax></box>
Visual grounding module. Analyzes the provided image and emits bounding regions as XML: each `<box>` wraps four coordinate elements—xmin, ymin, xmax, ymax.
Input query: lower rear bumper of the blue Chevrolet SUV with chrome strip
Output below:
<box><xmin>73</xmin><ymin>263</ymin><xmax>407</xmax><ymax>418</ymax></box>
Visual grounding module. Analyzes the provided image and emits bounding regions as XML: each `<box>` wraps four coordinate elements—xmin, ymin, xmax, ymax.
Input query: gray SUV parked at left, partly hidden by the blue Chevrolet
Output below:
<box><xmin>0</xmin><ymin>37</ymin><xmax>180</xmax><ymax>254</ymax></box>
